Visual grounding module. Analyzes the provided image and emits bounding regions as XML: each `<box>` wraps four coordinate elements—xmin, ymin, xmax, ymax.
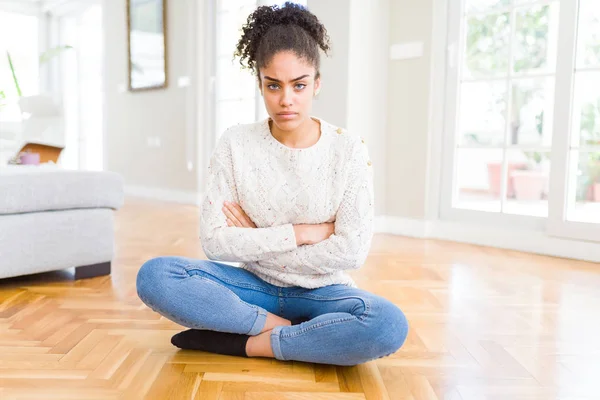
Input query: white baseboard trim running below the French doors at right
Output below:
<box><xmin>375</xmin><ymin>216</ymin><xmax>600</xmax><ymax>263</ymax></box>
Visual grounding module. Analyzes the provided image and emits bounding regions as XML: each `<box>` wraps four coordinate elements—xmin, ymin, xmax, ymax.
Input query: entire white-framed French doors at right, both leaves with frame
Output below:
<box><xmin>441</xmin><ymin>0</ymin><xmax>600</xmax><ymax>238</ymax></box>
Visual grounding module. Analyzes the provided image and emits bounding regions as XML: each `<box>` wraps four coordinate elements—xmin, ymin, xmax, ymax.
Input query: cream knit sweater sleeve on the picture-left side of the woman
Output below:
<box><xmin>200</xmin><ymin>131</ymin><xmax>297</xmax><ymax>262</ymax></box>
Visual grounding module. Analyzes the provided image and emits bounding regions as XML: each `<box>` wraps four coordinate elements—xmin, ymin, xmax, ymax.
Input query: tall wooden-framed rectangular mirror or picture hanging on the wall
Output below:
<box><xmin>127</xmin><ymin>0</ymin><xmax>168</xmax><ymax>92</ymax></box>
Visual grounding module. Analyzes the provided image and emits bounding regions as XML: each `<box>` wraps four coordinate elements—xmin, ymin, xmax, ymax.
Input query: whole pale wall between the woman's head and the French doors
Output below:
<box><xmin>308</xmin><ymin>0</ymin><xmax>433</xmax><ymax>218</ymax></box>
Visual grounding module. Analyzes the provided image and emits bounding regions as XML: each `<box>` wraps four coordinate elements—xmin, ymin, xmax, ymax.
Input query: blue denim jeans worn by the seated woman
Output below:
<box><xmin>137</xmin><ymin>257</ymin><xmax>408</xmax><ymax>365</ymax></box>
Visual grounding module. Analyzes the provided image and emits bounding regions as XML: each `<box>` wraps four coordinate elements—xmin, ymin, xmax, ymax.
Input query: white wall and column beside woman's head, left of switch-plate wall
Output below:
<box><xmin>308</xmin><ymin>0</ymin><xmax>389</xmax><ymax>215</ymax></box>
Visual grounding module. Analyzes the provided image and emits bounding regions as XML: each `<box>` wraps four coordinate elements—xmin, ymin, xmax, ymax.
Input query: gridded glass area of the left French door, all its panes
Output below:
<box><xmin>454</xmin><ymin>1</ymin><xmax>559</xmax><ymax>217</ymax></box>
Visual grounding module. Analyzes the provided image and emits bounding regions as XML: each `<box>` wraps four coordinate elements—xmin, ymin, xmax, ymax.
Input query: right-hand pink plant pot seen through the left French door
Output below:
<box><xmin>511</xmin><ymin>152</ymin><xmax>548</xmax><ymax>201</ymax></box>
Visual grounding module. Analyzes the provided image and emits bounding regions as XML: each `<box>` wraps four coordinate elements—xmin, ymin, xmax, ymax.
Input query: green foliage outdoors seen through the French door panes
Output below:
<box><xmin>464</xmin><ymin>0</ymin><xmax>600</xmax><ymax>200</ymax></box>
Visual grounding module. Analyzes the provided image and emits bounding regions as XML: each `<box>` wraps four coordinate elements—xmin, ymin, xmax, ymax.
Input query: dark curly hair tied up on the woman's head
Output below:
<box><xmin>234</xmin><ymin>2</ymin><xmax>330</xmax><ymax>79</ymax></box>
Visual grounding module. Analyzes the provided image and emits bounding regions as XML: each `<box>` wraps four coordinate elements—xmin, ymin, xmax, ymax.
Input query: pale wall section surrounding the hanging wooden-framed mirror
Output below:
<box><xmin>103</xmin><ymin>0</ymin><xmax>204</xmax><ymax>194</ymax></box>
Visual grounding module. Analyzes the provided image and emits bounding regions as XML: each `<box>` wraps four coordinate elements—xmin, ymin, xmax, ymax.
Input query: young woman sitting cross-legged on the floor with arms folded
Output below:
<box><xmin>137</xmin><ymin>3</ymin><xmax>408</xmax><ymax>365</ymax></box>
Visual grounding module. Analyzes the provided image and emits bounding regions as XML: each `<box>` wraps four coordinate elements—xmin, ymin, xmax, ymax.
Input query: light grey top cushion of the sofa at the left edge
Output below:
<box><xmin>0</xmin><ymin>165</ymin><xmax>124</xmax><ymax>215</ymax></box>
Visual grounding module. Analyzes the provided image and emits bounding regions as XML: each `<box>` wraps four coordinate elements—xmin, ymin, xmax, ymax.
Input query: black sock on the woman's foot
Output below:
<box><xmin>171</xmin><ymin>329</ymin><xmax>250</xmax><ymax>357</ymax></box>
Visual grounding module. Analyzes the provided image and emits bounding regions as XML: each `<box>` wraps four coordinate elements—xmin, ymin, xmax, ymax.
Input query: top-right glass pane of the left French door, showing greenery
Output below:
<box><xmin>513</xmin><ymin>3</ymin><xmax>558</xmax><ymax>73</ymax></box>
